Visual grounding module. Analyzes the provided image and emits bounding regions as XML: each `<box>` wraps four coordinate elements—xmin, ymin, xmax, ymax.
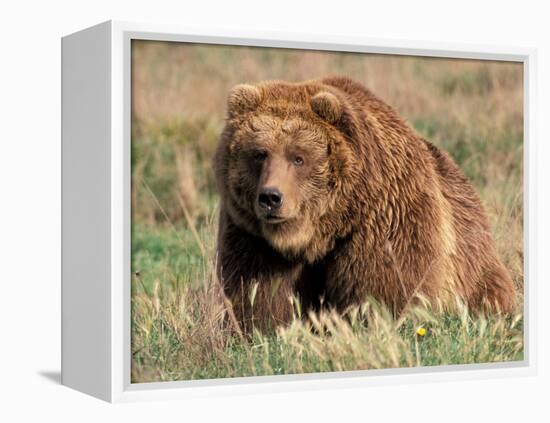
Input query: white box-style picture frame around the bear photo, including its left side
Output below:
<box><xmin>62</xmin><ymin>21</ymin><xmax>537</xmax><ymax>402</ymax></box>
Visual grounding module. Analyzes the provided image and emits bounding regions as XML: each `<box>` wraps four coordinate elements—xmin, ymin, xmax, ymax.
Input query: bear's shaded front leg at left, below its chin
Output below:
<box><xmin>218</xmin><ymin>218</ymin><xmax>302</xmax><ymax>334</ymax></box>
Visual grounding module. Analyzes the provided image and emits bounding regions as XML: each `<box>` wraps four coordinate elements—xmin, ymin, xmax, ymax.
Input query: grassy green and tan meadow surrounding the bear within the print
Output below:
<box><xmin>132</xmin><ymin>41</ymin><xmax>523</xmax><ymax>382</ymax></box>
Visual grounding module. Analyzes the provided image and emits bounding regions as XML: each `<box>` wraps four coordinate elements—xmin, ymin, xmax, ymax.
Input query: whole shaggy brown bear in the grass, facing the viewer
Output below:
<box><xmin>215</xmin><ymin>77</ymin><xmax>515</xmax><ymax>332</ymax></box>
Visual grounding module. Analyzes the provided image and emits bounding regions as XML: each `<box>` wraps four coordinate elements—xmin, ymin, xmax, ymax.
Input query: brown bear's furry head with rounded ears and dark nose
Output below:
<box><xmin>216</xmin><ymin>82</ymin><xmax>360</xmax><ymax>259</ymax></box>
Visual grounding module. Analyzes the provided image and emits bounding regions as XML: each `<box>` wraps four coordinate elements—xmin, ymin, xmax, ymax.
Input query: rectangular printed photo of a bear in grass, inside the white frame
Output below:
<box><xmin>131</xmin><ymin>40</ymin><xmax>524</xmax><ymax>383</ymax></box>
